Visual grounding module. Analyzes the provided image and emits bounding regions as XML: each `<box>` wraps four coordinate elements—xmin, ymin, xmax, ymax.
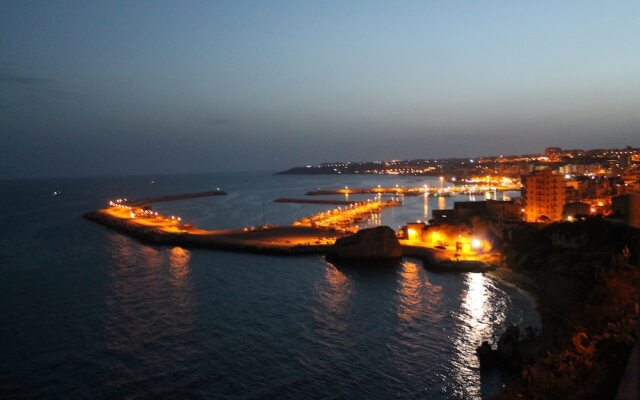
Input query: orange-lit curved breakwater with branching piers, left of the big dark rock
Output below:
<box><xmin>84</xmin><ymin>195</ymin><xmax>400</xmax><ymax>254</ymax></box>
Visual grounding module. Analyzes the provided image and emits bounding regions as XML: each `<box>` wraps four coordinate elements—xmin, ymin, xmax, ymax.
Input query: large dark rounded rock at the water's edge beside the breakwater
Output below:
<box><xmin>328</xmin><ymin>226</ymin><xmax>402</xmax><ymax>260</ymax></box>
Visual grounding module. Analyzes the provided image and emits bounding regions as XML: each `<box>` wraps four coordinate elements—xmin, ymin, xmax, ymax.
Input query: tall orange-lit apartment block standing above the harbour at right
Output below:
<box><xmin>522</xmin><ymin>170</ymin><xmax>566</xmax><ymax>222</ymax></box>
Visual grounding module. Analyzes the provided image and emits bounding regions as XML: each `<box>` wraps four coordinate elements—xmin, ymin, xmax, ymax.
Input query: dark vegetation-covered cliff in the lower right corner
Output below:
<box><xmin>496</xmin><ymin>219</ymin><xmax>640</xmax><ymax>399</ymax></box>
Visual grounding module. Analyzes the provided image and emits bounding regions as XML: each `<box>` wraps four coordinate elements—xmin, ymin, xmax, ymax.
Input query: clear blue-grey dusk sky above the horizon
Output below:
<box><xmin>0</xmin><ymin>0</ymin><xmax>640</xmax><ymax>177</ymax></box>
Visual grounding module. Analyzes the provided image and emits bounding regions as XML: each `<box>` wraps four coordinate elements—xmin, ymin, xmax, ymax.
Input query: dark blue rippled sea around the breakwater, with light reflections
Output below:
<box><xmin>0</xmin><ymin>174</ymin><xmax>539</xmax><ymax>399</ymax></box>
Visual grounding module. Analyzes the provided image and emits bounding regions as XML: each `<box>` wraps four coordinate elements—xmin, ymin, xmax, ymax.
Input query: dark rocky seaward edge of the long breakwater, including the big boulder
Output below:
<box><xmin>84</xmin><ymin>210</ymin><xmax>492</xmax><ymax>272</ymax></box>
